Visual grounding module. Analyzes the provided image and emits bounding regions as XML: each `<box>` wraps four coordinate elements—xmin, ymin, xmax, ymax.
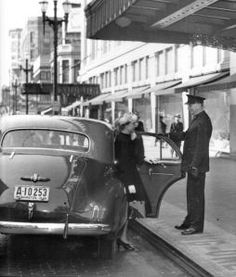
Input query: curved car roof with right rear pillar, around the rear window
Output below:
<box><xmin>0</xmin><ymin>115</ymin><xmax>114</xmax><ymax>163</ymax></box>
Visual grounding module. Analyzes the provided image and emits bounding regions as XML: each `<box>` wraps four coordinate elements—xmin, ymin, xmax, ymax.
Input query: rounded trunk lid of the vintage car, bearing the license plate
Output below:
<box><xmin>0</xmin><ymin>151</ymin><xmax>87</xmax><ymax>222</ymax></box>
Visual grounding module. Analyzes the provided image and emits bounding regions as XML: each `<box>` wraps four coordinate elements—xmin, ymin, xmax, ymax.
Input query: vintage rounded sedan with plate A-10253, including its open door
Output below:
<box><xmin>0</xmin><ymin>115</ymin><xmax>182</xmax><ymax>257</ymax></box>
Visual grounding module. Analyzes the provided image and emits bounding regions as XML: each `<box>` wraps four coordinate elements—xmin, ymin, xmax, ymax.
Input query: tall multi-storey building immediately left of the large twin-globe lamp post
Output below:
<box><xmin>21</xmin><ymin>17</ymin><xmax>57</xmax><ymax>114</ymax></box>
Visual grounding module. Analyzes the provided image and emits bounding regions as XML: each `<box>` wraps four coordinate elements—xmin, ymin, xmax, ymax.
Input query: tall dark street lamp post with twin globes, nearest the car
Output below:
<box><xmin>39</xmin><ymin>0</ymin><xmax>71</xmax><ymax>114</ymax></box>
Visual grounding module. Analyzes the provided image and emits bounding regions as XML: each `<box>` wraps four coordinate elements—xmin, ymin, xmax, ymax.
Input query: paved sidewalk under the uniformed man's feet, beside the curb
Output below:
<box><xmin>137</xmin><ymin>158</ymin><xmax>236</xmax><ymax>277</ymax></box>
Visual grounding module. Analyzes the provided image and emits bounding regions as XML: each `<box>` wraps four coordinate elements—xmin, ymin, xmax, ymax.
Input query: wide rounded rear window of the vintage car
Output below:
<box><xmin>2</xmin><ymin>129</ymin><xmax>89</xmax><ymax>152</ymax></box>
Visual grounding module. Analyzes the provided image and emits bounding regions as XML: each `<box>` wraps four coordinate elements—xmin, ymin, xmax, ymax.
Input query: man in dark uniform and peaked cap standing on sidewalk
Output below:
<box><xmin>170</xmin><ymin>95</ymin><xmax>212</xmax><ymax>235</ymax></box>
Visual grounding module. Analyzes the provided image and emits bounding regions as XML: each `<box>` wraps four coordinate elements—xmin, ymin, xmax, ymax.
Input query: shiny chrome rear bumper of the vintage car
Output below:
<box><xmin>0</xmin><ymin>221</ymin><xmax>111</xmax><ymax>235</ymax></box>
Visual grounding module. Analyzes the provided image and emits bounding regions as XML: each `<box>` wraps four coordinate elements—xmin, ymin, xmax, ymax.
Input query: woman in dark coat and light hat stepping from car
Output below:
<box><xmin>115</xmin><ymin>113</ymin><xmax>150</xmax><ymax>250</ymax></box>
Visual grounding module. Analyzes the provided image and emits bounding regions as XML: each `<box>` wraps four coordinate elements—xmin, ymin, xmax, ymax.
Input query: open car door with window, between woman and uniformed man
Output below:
<box><xmin>139</xmin><ymin>133</ymin><xmax>184</xmax><ymax>217</ymax></box>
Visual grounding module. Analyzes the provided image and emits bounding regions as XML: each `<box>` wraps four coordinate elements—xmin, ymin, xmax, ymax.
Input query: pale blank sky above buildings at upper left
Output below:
<box><xmin>0</xmin><ymin>0</ymin><xmax>63</xmax><ymax>88</ymax></box>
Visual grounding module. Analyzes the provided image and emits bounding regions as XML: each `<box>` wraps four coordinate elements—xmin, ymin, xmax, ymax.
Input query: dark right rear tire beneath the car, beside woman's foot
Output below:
<box><xmin>98</xmin><ymin>237</ymin><xmax>116</xmax><ymax>259</ymax></box>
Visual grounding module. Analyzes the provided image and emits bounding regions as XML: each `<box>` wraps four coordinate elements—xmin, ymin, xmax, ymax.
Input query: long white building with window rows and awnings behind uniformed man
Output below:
<box><xmin>79</xmin><ymin>1</ymin><xmax>232</xmax><ymax>154</ymax></box>
